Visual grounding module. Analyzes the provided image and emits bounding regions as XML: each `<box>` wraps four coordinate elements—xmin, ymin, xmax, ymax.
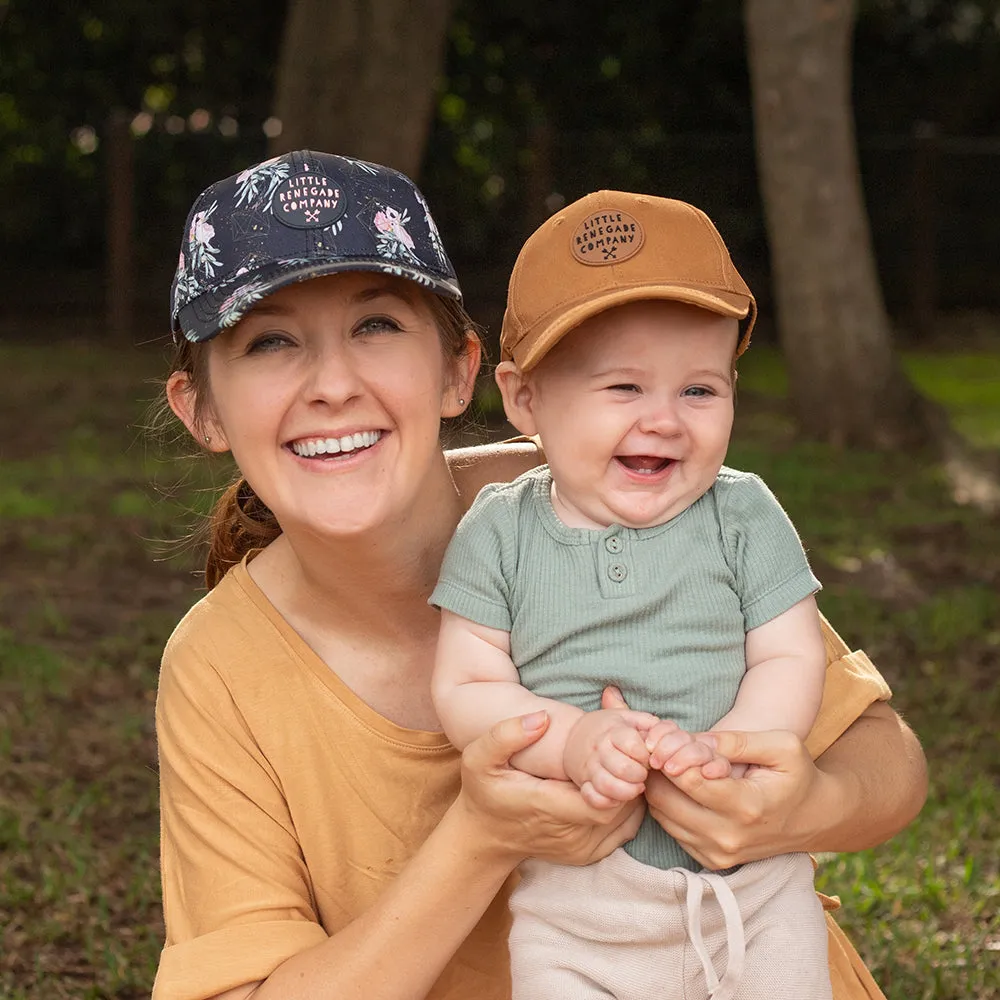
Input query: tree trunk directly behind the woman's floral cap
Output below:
<box><xmin>271</xmin><ymin>0</ymin><xmax>451</xmax><ymax>176</ymax></box>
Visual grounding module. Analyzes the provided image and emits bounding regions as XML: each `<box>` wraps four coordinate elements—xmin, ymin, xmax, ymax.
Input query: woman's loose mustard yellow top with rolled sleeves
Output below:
<box><xmin>153</xmin><ymin>564</ymin><xmax>889</xmax><ymax>1000</ymax></box>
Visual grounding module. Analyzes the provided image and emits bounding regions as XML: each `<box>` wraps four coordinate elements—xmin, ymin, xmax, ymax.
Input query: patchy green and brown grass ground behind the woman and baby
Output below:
<box><xmin>0</xmin><ymin>334</ymin><xmax>1000</xmax><ymax>1000</ymax></box>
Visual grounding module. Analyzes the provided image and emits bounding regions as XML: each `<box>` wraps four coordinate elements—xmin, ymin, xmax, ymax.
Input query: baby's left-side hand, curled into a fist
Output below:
<box><xmin>563</xmin><ymin>709</ymin><xmax>657</xmax><ymax>809</ymax></box>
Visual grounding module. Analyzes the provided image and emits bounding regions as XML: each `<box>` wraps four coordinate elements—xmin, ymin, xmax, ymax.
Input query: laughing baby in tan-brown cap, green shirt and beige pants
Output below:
<box><xmin>431</xmin><ymin>191</ymin><xmax>831</xmax><ymax>1000</ymax></box>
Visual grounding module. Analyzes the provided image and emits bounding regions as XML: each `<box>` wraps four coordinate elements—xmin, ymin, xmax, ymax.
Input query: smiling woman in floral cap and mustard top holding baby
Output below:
<box><xmin>154</xmin><ymin>152</ymin><xmax>924</xmax><ymax>1000</ymax></box>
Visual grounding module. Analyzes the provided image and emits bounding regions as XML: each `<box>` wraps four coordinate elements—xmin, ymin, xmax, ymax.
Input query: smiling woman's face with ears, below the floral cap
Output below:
<box><xmin>168</xmin><ymin>272</ymin><xmax>479</xmax><ymax>537</ymax></box>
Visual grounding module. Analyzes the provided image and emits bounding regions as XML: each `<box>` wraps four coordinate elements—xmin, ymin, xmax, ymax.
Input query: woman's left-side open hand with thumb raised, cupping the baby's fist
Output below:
<box><xmin>456</xmin><ymin>712</ymin><xmax>645</xmax><ymax>867</ymax></box>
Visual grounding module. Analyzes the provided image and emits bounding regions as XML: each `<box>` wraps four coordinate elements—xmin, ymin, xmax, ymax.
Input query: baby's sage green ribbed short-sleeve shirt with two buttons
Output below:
<box><xmin>431</xmin><ymin>466</ymin><xmax>819</xmax><ymax>867</ymax></box>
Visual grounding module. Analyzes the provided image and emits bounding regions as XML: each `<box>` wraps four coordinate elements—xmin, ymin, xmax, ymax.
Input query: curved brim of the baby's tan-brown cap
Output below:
<box><xmin>511</xmin><ymin>285</ymin><xmax>757</xmax><ymax>371</ymax></box>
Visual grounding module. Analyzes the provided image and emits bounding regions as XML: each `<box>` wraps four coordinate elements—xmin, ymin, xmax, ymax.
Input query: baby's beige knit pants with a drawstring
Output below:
<box><xmin>510</xmin><ymin>849</ymin><xmax>832</xmax><ymax>1000</ymax></box>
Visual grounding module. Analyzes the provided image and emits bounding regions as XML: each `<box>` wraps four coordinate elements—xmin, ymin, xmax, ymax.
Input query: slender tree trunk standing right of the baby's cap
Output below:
<box><xmin>745</xmin><ymin>0</ymin><xmax>946</xmax><ymax>448</ymax></box>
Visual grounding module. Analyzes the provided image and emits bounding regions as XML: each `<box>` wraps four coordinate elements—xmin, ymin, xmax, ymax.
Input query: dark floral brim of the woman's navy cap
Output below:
<box><xmin>173</xmin><ymin>257</ymin><xmax>462</xmax><ymax>344</ymax></box>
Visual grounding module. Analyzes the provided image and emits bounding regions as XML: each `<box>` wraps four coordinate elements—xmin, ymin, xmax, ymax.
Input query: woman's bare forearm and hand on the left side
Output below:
<box><xmin>203</xmin><ymin>715</ymin><xmax>643</xmax><ymax>1000</ymax></box>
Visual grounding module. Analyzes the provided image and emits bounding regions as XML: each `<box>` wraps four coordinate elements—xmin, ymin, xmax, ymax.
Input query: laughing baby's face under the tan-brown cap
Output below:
<box><xmin>528</xmin><ymin>301</ymin><xmax>738</xmax><ymax>528</ymax></box>
